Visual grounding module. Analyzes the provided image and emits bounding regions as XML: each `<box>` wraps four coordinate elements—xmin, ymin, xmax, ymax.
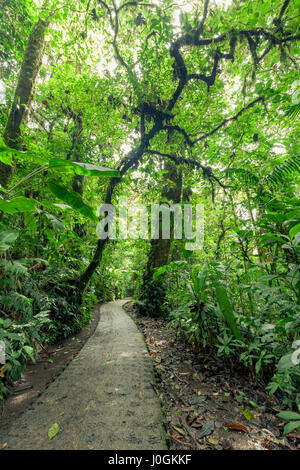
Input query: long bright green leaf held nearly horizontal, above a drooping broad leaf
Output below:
<box><xmin>49</xmin><ymin>158</ymin><xmax>120</xmax><ymax>178</ymax></box>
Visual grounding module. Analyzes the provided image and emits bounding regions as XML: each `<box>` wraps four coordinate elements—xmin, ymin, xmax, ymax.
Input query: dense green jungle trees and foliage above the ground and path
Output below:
<box><xmin>0</xmin><ymin>0</ymin><xmax>300</xmax><ymax>430</ymax></box>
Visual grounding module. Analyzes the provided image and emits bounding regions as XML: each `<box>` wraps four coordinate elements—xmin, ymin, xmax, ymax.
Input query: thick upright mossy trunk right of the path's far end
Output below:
<box><xmin>140</xmin><ymin>160</ymin><xmax>182</xmax><ymax>316</ymax></box>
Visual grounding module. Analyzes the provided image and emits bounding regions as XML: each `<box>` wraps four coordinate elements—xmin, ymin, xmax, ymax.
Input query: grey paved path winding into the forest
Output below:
<box><xmin>0</xmin><ymin>300</ymin><xmax>166</xmax><ymax>450</ymax></box>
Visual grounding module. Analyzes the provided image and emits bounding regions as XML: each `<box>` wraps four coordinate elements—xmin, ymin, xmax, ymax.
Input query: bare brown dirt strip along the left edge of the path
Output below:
<box><xmin>0</xmin><ymin>305</ymin><xmax>100</xmax><ymax>431</ymax></box>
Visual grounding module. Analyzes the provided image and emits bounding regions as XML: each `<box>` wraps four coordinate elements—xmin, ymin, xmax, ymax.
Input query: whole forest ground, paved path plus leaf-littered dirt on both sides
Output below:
<box><xmin>0</xmin><ymin>301</ymin><xmax>300</xmax><ymax>450</ymax></box>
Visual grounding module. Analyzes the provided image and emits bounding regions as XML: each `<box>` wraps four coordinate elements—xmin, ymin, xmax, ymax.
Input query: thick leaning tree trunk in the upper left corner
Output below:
<box><xmin>0</xmin><ymin>19</ymin><xmax>48</xmax><ymax>187</ymax></box>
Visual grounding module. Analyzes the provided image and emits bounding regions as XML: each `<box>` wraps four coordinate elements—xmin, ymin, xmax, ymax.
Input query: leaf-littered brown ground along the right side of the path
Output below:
<box><xmin>124</xmin><ymin>302</ymin><xmax>300</xmax><ymax>450</ymax></box>
